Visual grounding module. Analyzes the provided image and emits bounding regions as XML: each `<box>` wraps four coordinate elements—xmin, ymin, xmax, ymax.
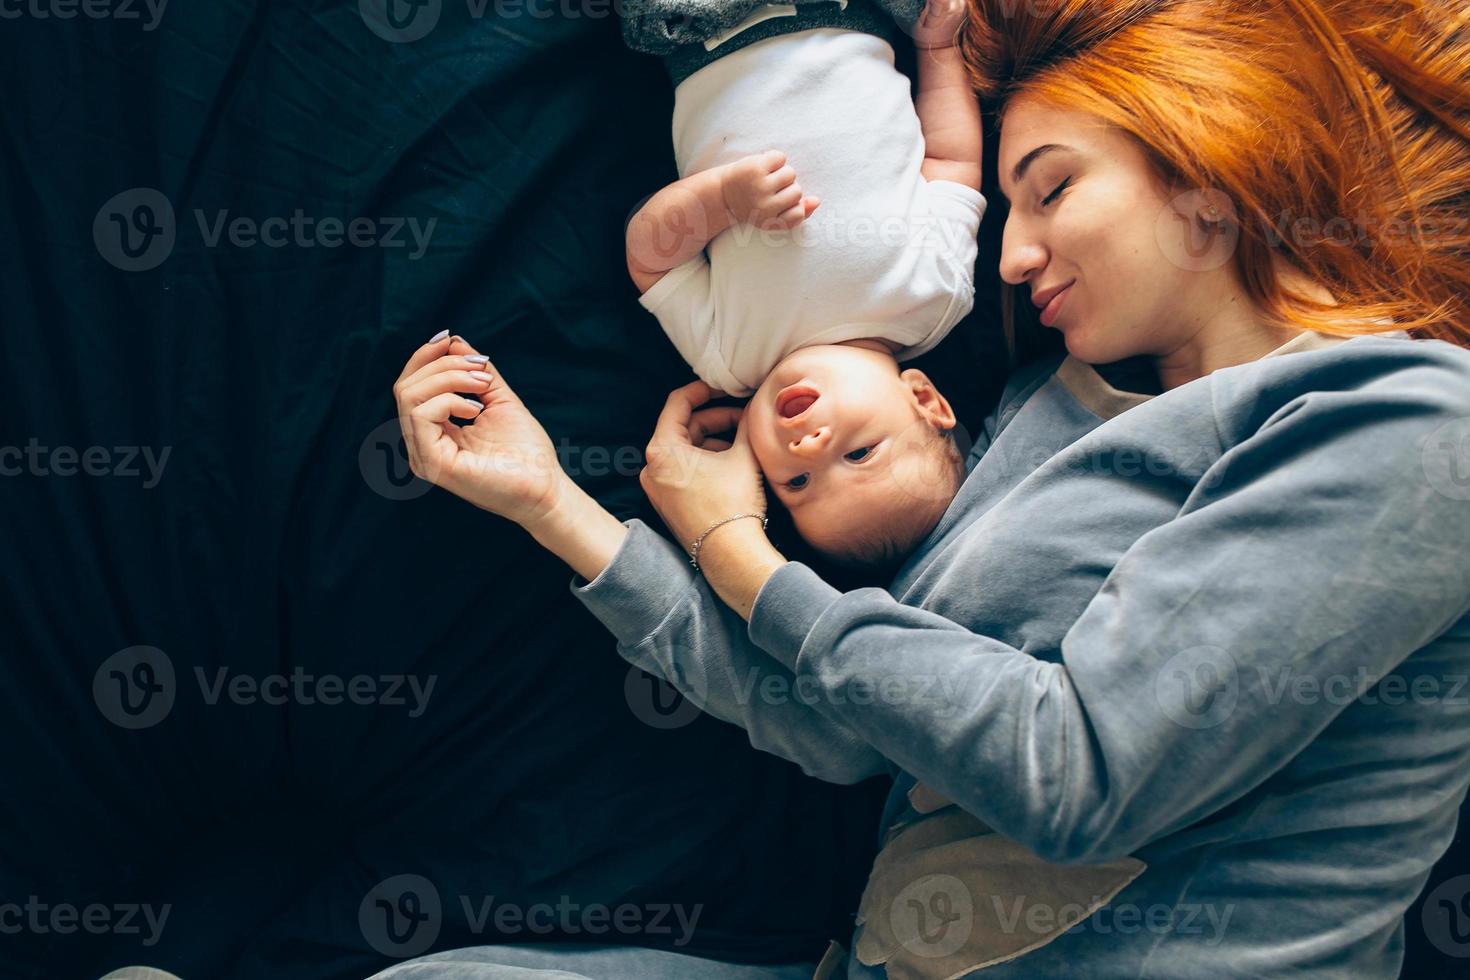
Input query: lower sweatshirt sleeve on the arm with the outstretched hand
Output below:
<box><xmin>572</xmin><ymin>519</ymin><xmax>891</xmax><ymax>783</ymax></box>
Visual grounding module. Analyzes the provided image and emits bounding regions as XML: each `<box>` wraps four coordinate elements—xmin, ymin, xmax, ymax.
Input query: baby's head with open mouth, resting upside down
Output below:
<box><xmin>745</xmin><ymin>344</ymin><xmax>964</xmax><ymax>567</ymax></box>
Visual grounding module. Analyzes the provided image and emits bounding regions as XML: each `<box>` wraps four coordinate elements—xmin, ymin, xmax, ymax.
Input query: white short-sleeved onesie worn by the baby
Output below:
<box><xmin>639</xmin><ymin>28</ymin><xmax>985</xmax><ymax>395</ymax></box>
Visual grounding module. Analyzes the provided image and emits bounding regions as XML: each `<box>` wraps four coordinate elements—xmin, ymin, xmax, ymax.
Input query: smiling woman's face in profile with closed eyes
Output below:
<box><xmin>1000</xmin><ymin>97</ymin><xmax>1239</xmax><ymax>364</ymax></box>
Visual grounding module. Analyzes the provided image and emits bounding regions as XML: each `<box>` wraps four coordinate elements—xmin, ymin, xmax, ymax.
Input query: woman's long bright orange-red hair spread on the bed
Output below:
<box><xmin>961</xmin><ymin>0</ymin><xmax>1470</xmax><ymax>347</ymax></box>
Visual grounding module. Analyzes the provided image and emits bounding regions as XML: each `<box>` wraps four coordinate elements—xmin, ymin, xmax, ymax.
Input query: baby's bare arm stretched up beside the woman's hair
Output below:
<box><xmin>913</xmin><ymin>0</ymin><xmax>983</xmax><ymax>190</ymax></box>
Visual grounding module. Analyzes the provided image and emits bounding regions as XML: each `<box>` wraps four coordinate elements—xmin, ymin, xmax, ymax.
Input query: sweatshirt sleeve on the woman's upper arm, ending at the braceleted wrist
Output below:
<box><xmin>751</xmin><ymin>365</ymin><xmax>1470</xmax><ymax>862</ymax></box>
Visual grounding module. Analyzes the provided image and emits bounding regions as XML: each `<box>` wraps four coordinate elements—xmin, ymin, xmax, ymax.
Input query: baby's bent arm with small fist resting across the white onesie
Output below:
<box><xmin>626</xmin><ymin>150</ymin><xmax>820</xmax><ymax>292</ymax></box>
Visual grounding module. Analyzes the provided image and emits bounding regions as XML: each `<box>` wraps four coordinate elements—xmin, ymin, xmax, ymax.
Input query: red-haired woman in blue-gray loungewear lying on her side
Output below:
<box><xmin>382</xmin><ymin>0</ymin><xmax>1470</xmax><ymax>979</ymax></box>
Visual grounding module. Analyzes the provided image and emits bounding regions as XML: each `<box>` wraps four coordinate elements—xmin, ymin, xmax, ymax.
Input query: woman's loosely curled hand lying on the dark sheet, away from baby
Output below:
<box><xmin>392</xmin><ymin>336</ymin><xmax>570</xmax><ymax>527</ymax></box>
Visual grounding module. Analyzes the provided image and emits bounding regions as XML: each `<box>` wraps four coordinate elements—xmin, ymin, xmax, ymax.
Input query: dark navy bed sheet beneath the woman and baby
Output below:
<box><xmin>0</xmin><ymin>0</ymin><xmax>1458</xmax><ymax>980</ymax></box>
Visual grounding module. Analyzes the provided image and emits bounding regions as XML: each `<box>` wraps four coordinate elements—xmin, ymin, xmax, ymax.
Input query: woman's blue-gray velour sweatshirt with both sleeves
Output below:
<box><xmin>572</xmin><ymin>334</ymin><xmax>1470</xmax><ymax>980</ymax></box>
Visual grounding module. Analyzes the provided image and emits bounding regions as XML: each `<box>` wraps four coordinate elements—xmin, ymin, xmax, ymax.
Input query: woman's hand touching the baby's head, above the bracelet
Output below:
<box><xmin>638</xmin><ymin>381</ymin><xmax>766</xmax><ymax>551</ymax></box>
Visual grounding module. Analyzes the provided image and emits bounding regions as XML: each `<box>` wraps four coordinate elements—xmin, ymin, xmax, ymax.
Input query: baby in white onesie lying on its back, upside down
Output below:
<box><xmin>626</xmin><ymin>0</ymin><xmax>985</xmax><ymax>566</ymax></box>
